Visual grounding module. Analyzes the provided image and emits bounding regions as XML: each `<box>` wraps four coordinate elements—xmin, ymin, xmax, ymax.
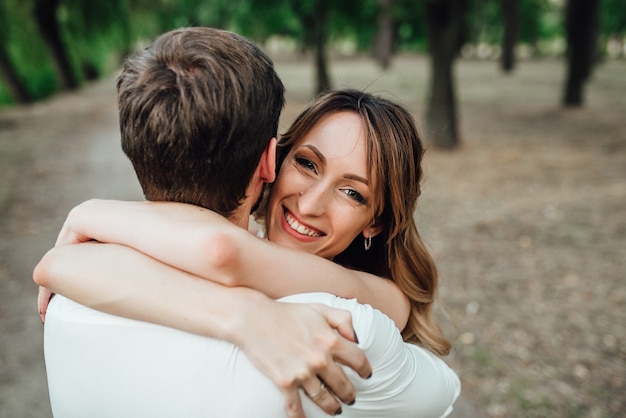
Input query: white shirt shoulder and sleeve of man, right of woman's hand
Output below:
<box><xmin>283</xmin><ymin>293</ymin><xmax>461</xmax><ymax>418</ymax></box>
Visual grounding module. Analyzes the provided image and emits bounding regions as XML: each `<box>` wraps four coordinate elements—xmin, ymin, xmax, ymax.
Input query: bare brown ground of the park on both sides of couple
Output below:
<box><xmin>0</xmin><ymin>57</ymin><xmax>626</xmax><ymax>418</ymax></box>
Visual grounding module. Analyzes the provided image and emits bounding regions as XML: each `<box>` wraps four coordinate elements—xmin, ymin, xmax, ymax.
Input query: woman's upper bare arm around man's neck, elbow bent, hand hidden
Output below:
<box><xmin>58</xmin><ymin>200</ymin><xmax>410</xmax><ymax>329</ymax></box>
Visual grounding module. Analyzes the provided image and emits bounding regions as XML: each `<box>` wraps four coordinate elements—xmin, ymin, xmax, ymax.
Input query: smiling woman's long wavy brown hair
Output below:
<box><xmin>258</xmin><ymin>90</ymin><xmax>451</xmax><ymax>356</ymax></box>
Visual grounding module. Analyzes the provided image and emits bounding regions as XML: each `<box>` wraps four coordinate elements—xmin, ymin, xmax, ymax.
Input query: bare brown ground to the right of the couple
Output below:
<box><xmin>285</xmin><ymin>57</ymin><xmax>626</xmax><ymax>418</ymax></box>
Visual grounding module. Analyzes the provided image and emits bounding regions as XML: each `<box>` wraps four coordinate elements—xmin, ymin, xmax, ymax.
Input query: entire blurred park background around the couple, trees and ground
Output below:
<box><xmin>0</xmin><ymin>0</ymin><xmax>626</xmax><ymax>418</ymax></box>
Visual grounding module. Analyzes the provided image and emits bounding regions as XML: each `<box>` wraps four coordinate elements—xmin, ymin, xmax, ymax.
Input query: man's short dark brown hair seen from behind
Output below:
<box><xmin>117</xmin><ymin>27</ymin><xmax>284</xmax><ymax>216</ymax></box>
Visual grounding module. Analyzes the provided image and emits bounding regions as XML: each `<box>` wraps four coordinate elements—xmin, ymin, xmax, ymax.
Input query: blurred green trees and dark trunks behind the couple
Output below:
<box><xmin>0</xmin><ymin>0</ymin><xmax>626</xmax><ymax>148</ymax></box>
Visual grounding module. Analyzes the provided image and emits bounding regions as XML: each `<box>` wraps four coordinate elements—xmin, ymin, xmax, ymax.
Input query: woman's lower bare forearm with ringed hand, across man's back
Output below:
<box><xmin>33</xmin><ymin>243</ymin><xmax>371</xmax><ymax>413</ymax></box>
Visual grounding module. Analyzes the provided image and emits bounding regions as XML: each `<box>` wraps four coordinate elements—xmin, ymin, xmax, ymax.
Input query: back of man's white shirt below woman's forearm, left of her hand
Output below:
<box><xmin>44</xmin><ymin>295</ymin><xmax>285</xmax><ymax>418</ymax></box>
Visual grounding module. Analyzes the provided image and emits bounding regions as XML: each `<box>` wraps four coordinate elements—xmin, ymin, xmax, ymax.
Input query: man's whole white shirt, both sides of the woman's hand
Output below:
<box><xmin>44</xmin><ymin>293</ymin><xmax>460</xmax><ymax>418</ymax></box>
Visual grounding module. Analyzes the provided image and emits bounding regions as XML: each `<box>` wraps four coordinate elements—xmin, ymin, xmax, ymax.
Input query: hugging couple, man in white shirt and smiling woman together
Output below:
<box><xmin>34</xmin><ymin>27</ymin><xmax>460</xmax><ymax>418</ymax></box>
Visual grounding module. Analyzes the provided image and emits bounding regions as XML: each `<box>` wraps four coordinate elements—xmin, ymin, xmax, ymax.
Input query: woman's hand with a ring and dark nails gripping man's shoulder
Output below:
<box><xmin>237</xmin><ymin>301</ymin><xmax>372</xmax><ymax>417</ymax></box>
